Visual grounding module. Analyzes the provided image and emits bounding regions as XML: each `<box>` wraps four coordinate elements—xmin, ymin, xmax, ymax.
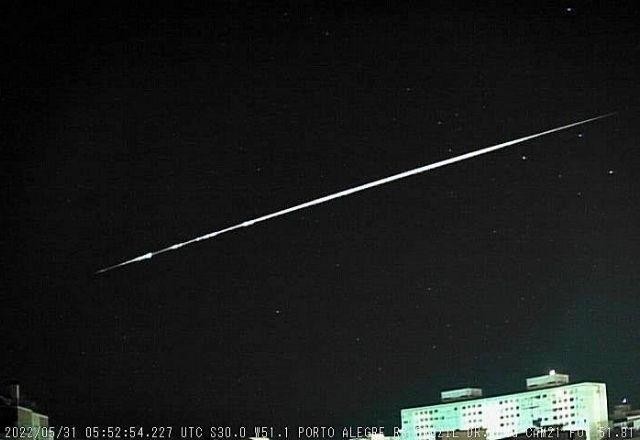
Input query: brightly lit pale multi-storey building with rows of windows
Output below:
<box><xmin>401</xmin><ymin>371</ymin><xmax>608</xmax><ymax>440</ymax></box>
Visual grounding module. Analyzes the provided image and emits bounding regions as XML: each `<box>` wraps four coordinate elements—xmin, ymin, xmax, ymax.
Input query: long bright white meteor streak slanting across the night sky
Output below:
<box><xmin>96</xmin><ymin>113</ymin><xmax>615</xmax><ymax>274</ymax></box>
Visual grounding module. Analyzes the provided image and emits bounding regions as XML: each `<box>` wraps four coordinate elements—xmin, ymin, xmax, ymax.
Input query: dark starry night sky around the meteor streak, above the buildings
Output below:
<box><xmin>0</xmin><ymin>1</ymin><xmax>640</xmax><ymax>432</ymax></box>
